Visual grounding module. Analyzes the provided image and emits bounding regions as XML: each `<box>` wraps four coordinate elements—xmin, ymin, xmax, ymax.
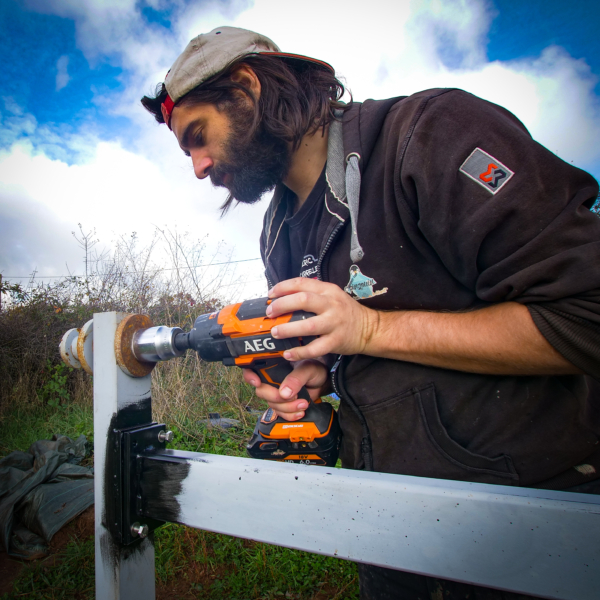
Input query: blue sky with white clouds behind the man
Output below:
<box><xmin>0</xmin><ymin>0</ymin><xmax>600</xmax><ymax>290</ymax></box>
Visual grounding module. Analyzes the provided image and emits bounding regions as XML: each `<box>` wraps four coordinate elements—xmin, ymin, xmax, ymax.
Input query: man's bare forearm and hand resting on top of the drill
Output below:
<box><xmin>267</xmin><ymin>278</ymin><xmax>581</xmax><ymax>375</ymax></box>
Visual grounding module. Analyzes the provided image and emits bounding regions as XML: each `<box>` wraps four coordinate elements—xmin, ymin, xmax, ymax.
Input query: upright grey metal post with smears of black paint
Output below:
<box><xmin>93</xmin><ymin>312</ymin><xmax>155</xmax><ymax>600</ymax></box>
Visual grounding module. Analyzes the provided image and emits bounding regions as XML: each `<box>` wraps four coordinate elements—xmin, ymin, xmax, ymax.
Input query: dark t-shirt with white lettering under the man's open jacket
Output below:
<box><xmin>285</xmin><ymin>168</ymin><xmax>327</xmax><ymax>279</ymax></box>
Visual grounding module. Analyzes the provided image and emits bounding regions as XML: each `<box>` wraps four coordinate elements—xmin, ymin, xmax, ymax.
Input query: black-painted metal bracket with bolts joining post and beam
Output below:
<box><xmin>117</xmin><ymin>423</ymin><xmax>168</xmax><ymax>545</ymax></box>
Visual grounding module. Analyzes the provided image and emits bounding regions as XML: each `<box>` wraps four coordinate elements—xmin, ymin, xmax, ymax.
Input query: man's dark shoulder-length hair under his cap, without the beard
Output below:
<box><xmin>141</xmin><ymin>54</ymin><xmax>351</xmax><ymax>150</ymax></box>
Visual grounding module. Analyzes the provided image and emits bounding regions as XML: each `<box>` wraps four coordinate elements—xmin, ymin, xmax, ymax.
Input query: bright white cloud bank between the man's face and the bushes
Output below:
<box><xmin>0</xmin><ymin>135</ymin><xmax>265</xmax><ymax>295</ymax></box>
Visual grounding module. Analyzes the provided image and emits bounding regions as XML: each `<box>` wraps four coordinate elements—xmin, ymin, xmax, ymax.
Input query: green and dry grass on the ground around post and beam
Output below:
<box><xmin>0</xmin><ymin>366</ymin><xmax>358</xmax><ymax>600</ymax></box>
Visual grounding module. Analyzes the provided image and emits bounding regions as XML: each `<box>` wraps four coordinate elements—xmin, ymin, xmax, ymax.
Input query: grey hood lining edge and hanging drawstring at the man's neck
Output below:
<box><xmin>325</xmin><ymin>111</ymin><xmax>365</xmax><ymax>263</ymax></box>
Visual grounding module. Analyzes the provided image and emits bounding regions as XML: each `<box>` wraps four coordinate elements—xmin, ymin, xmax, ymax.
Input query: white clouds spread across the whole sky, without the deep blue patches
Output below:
<box><xmin>0</xmin><ymin>0</ymin><xmax>600</xmax><ymax>300</ymax></box>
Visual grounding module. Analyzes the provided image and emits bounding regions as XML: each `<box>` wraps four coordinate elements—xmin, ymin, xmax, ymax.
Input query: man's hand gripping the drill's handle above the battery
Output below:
<box><xmin>244</xmin><ymin>360</ymin><xmax>329</xmax><ymax>421</ymax></box>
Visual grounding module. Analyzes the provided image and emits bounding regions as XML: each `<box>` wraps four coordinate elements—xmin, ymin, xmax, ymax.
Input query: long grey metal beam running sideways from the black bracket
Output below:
<box><xmin>143</xmin><ymin>450</ymin><xmax>600</xmax><ymax>600</ymax></box>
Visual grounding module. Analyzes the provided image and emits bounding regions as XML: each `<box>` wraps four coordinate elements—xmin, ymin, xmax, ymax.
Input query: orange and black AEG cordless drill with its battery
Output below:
<box><xmin>173</xmin><ymin>298</ymin><xmax>341</xmax><ymax>467</ymax></box>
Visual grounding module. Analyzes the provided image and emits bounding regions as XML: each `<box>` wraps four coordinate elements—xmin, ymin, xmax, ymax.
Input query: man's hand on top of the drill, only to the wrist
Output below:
<box><xmin>267</xmin><ymin>277</ymin><xmax>379</xmax><ymax>360</ymax></box>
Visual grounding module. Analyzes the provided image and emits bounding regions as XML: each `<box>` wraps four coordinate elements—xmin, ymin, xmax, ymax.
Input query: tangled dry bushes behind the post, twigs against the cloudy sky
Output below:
<box><xmin>0</xmin><ymin>226</ymin><xmax>248</xmax><ymax>415</ymax></box>
